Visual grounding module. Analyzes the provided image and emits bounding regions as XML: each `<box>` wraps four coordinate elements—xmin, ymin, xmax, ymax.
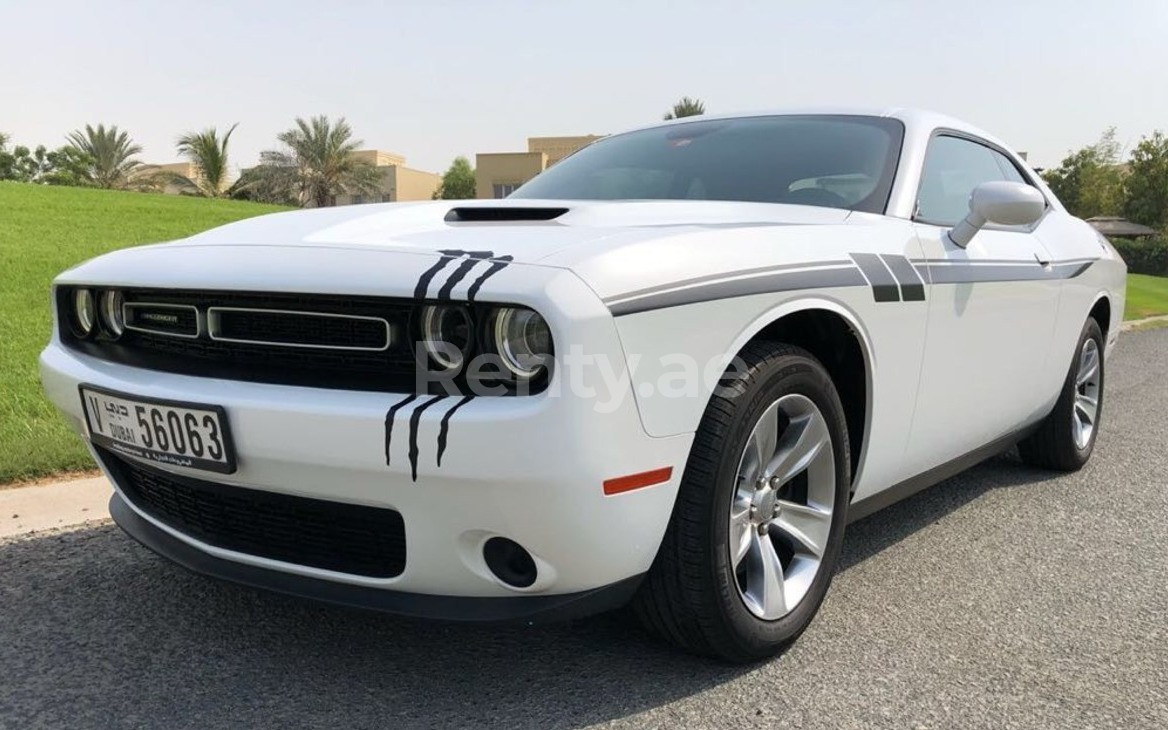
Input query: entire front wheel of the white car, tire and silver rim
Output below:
<box><xmin>634</xmin><ymin>343</ymin><xmax>850</xmax><ymax>661</ymax></box>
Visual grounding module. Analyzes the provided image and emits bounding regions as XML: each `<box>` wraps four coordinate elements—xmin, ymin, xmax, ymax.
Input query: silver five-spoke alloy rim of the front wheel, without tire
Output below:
<box><xmin>728</xmin><ymin>394</ymin><xmax>835</xmax><ymax>620</ymax></box>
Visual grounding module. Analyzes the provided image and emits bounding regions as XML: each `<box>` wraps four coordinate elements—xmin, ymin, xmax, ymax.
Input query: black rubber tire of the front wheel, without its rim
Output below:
<box><xmin>633</xmin><ymin>342</ymin><xmax>851</xmax><ymax>662</ymax></box>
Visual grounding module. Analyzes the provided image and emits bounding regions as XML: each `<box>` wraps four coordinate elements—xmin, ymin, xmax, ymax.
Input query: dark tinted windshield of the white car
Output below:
<box><xmin>509</xmin><ymin>116</ymin><xmax>904</xmax><ymax>213</ymax></box>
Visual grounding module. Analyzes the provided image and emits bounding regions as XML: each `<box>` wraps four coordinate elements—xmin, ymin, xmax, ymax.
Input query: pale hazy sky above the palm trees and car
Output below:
<box><xmin>0</xmin><ymin>0</ymin><xmax>1168</xmax><ymax>172</ymax></box>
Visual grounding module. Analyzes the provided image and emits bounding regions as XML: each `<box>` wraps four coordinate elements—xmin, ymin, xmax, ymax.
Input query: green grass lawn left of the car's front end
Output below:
<box><xmin>0</xmin><ymin>182</ymin><xmax>288</xmax><ymax>484</ymax></box>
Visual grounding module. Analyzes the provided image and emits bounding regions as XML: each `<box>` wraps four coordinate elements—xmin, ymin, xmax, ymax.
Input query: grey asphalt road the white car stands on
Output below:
<box><xmin>0</xmin><ymin>329</ymin><xmax>1168</xmax><ymax>730</ymax></box>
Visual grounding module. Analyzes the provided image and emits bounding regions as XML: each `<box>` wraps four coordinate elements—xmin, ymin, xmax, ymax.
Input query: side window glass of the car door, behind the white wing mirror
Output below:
<box><xmin>916</xmin><ymin>137</ymin><xmax>1026</xmax><ymax>225</ymax></box>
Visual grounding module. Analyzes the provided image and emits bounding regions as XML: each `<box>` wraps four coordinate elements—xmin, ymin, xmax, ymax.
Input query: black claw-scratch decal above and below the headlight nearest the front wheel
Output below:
<box><xmin>385</xmin><ymin>249</ymin><xmax>514</xmax><ymax>481</ymax></box>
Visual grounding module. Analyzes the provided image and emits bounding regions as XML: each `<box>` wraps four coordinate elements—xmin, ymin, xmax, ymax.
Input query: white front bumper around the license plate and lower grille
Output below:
<box><xmin>41</xmin><ymin>338</ymin><xmax>693</xmax><ymax>607</ymax></box>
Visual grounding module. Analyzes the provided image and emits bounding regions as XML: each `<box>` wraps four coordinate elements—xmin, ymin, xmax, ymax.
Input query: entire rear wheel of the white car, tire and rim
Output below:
<box><xmin>1018</xmin><ymin>318</ymin><xmax>1104</xmax><ymax>472</ymax></box>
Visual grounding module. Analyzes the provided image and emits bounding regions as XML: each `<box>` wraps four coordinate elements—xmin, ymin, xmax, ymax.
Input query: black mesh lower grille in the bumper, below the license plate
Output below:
<box><xmin>98</xmin><ymin>449</ymin><xmax>405</xmax><ymax>578</ymax></box>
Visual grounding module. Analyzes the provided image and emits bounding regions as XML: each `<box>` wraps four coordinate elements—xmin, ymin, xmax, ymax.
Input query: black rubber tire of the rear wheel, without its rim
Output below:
<box><xmin>1018</xmin><ymin>318</ymin><xmax>1106</xmax><ymax>472</ymax></box>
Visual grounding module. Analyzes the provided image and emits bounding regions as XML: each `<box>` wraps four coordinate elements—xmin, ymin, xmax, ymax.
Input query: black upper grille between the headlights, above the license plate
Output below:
<box><xmin>58</xmin><ymin>287</ymin><xmax>418</xmax><ymax>392</ymax></box>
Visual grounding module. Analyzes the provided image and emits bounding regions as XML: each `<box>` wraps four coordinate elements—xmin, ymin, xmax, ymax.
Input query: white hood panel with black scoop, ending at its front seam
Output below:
<box><xmin>181</xmin><ymin>200</ymin><xmax>849</xmax><ymax>266</ymax></box>
